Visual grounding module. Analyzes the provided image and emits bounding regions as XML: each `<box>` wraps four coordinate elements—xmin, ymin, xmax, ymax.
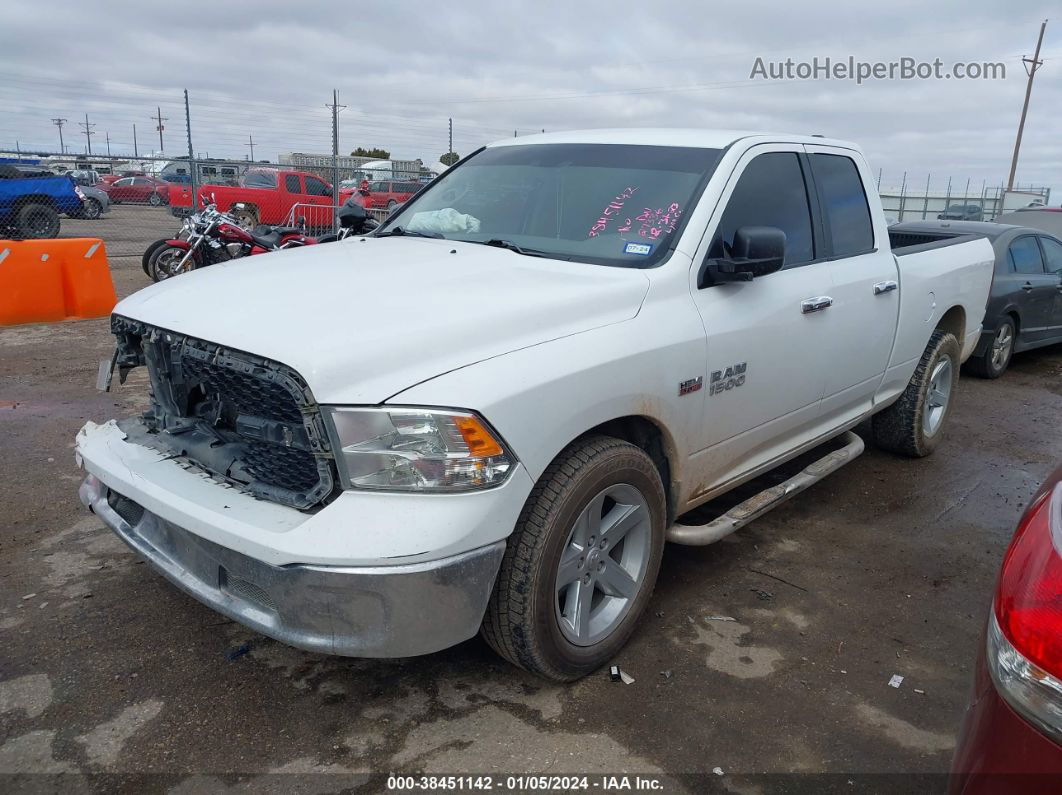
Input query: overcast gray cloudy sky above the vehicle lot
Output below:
<box><xmin>0</xmin><ymin>0</ymin><xmax>1062</xmax><ymax>198</ymax></box>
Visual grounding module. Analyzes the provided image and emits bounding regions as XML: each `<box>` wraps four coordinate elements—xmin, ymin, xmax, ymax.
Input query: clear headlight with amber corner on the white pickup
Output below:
<box><xmin>325</xmin><ymin>407</ymin><xmax>515</xmax><ymax>491</ymax></box>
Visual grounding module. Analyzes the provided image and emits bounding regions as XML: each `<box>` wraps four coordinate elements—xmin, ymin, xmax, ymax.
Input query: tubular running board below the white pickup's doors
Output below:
<box><xmin>667</xmin><ymin>431</ymin><xmax>863</xmax><ymax>547</ymax></box>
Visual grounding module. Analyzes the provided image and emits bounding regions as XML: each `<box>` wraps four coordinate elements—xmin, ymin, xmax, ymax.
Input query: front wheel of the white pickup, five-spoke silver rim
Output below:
<box><xmin>481</xmin><ymin>436</ymin><xmax>667</xmax><ymax>681</ymax></box>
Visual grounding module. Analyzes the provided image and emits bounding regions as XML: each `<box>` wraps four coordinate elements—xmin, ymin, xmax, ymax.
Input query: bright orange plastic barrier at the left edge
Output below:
<box><xmin>0</xmin><ymin>238</ymin><xmax>118</xmax><ymax>326</ymax></box>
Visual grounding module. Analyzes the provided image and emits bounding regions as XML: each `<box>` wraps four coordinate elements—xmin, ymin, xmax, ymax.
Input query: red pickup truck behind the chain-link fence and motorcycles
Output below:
<box><xmin>170</xmin><ymin>169</ymin><xmax>332</xmax><ymax>229</ymax></box>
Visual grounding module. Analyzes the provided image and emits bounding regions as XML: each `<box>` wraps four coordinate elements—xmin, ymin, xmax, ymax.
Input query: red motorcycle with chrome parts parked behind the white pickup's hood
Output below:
<box><xmin>141</xmin><ymin>204</ymin><xmax>318</xmax><ymax>281</ymax></box>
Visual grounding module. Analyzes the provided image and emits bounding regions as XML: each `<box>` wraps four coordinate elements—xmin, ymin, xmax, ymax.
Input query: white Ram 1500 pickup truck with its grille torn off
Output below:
<box><xmin>76</xmin><ymin>129</ymin><xmax>993</xmax><ymax>680</ymax></box>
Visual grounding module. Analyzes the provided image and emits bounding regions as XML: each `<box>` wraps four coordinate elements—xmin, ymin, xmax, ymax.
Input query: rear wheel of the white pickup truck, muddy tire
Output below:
<box><xmin>871</xmin><ymin>329</ymin><xmax>961</xmax><ymax>457</ymax></box>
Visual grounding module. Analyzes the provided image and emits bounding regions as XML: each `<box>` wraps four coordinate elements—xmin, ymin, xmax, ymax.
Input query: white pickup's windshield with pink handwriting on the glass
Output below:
<box><xmin>377</xmin><ymin>143</ymin><xmax>720</xmax><ymax>267</ymax></box>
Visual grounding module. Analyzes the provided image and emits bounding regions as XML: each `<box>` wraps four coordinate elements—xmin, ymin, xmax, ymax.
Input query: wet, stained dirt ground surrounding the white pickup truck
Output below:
<box><xmin>0</xmin><ymin>255</ymin><xmax>1062</xmax><ymax>793</ymax></box>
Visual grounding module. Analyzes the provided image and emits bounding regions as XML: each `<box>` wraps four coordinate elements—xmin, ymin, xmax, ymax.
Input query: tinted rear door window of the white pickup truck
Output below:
<box><xmin>810</xmin><ymin>154</ymin><xmax>874</xmax><ymax>257</ymax></box>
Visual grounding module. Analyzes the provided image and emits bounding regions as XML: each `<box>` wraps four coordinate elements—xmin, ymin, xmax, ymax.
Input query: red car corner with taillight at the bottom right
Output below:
<box><xmin>949</xmin><ymin>467</ymin><xmax>1062</xmax><ymax>795</ymax></box>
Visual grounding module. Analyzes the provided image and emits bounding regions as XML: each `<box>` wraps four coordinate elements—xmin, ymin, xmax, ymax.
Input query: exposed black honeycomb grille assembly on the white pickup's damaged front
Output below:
<box><xmin>112</xmin><ymin>315</ymin><xmax>337</xmax><ymax>509</ymax></box>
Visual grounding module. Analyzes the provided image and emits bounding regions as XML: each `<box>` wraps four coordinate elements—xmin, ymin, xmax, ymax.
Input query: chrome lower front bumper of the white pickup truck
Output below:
<box><xmin>79</xmin><ymin>474</ymin><xmax>506</xmax><ymax>657</ymax></box>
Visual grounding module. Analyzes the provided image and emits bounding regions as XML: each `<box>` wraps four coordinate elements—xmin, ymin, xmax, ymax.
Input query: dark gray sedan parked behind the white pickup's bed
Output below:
<box><xmin>889</xmin><ymin>221</ymin><xmax>1062</xmax><ymax>378</ymax></box>
